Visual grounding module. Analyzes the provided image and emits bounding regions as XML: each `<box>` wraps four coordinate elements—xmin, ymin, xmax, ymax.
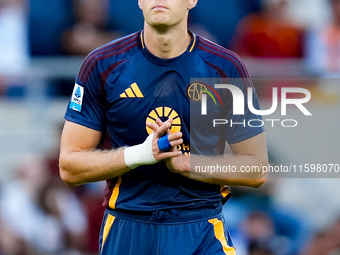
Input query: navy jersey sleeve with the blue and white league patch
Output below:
<box><xmin>65</xmin><ymin>53</ymin><xmax>105</xmax><ymax>131</ymax></box>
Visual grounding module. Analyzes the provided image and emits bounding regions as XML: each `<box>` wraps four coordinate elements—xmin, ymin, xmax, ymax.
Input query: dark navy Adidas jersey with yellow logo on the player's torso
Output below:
<box><xmin>65</xmin><ymin>32</ymin><xmax>263</xmax><ymax>211</ymax></box>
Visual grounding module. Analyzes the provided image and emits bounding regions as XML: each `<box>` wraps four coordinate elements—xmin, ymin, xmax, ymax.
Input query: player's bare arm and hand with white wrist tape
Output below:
<box><xmin>59</xmin><ymin>119</ymin><xmax>183</xmax><ymax>186</ymax></box>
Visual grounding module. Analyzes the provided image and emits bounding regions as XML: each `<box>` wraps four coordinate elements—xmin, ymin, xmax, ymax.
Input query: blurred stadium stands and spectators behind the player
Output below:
<box><xmin>0</xmin><ymin>0</ymin><xmax>340</xmax><ymax>255</ymax></box>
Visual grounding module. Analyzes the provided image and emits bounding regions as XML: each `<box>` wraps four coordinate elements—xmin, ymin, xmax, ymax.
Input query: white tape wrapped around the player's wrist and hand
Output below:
<box><xmin>124</xmin><ymin>133</ymin><xmax>158</xmax><ymax>169</ymax></box>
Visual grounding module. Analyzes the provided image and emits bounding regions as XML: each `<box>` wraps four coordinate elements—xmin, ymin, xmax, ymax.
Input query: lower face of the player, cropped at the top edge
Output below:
<box><xmin>138</xmin><ymin>0</ymin><xmax>197</xmax><ymax>27</ymax></box>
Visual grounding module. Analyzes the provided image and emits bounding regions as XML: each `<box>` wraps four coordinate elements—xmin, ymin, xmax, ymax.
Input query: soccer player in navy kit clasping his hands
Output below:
<box><xmin>59</xmin><ymin>0</ymin><xmax>267</xmax><ymax>255</ymax></box>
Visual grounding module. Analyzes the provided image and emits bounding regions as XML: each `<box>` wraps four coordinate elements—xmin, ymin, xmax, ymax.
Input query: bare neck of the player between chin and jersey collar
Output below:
<box><xmin>144</xmin><ymin>20</ymin><xmax>191</xmax><ymax>59</ymax></box>
